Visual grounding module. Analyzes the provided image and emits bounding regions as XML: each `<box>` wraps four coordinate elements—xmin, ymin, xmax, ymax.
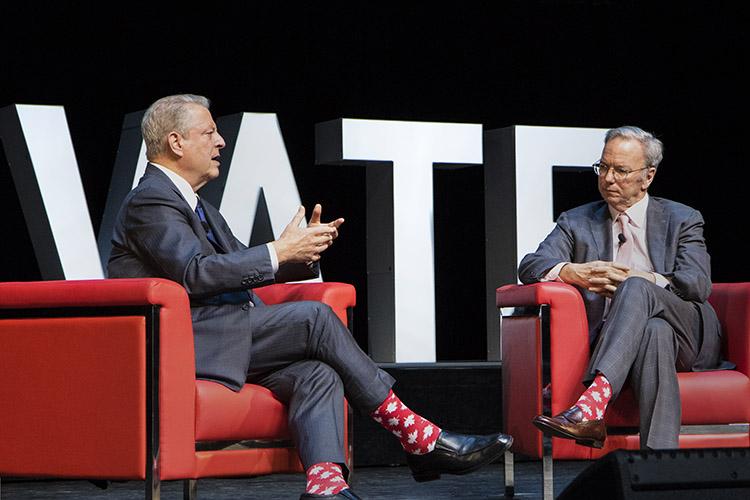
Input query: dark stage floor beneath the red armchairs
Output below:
<box><xmin>0</xmin><ymin>461</ymin><xmax>591</xmax><ymax>500</ymax></box>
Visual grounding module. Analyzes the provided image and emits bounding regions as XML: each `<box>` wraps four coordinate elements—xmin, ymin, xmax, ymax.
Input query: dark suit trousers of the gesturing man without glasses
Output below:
<box><xmin>247</xmin><ymin>302</ymin><xmax>395</xmax><ymax>469</ymax></box>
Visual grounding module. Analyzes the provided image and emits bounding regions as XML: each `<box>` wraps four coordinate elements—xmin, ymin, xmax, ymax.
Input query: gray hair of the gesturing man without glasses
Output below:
<box><xmin>141</xmin><ymin>94</ymin><xmax>211</xmax><ymax>160</ymax></box>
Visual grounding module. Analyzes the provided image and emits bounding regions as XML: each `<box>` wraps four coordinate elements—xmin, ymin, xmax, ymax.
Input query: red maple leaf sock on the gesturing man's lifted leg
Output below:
<box><xmin>370</xmin><ymin>391</ymin><xmax>441</xmax><ymax>455</ymax></box>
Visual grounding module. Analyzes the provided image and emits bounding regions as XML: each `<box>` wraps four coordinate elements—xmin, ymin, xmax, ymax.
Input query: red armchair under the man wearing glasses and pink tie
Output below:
<box><xmin>496</xmin><ymin>283</ymin><xmax>750</xmax><ymax>492</ymax></box>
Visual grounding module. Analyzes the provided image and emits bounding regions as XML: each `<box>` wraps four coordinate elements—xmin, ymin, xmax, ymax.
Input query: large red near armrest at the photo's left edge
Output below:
<box><xmin>0</xmin><ymin>278</ymin><xmax>195</xmax><ymax>479</ymax></box>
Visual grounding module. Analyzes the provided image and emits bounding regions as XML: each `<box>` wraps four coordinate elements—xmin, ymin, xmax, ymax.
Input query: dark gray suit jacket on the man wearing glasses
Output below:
<box><xmin>518</xmin><ymin>197</ymin><xmax>721</xmax><ymax>371</ymax></box>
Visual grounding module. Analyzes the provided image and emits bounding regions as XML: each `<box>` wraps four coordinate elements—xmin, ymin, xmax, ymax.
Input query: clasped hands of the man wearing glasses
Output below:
<box><xmin>560</xmin><ymin>260</ymin><xmax>655</xmax><ymax>297</ymax></box>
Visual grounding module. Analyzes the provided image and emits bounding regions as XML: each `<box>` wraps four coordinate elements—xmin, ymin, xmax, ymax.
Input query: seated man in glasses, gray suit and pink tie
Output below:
<box><xmin>518</xmin><ymin>127</ymin><xmax>721</xmax><ymax>449</ymax></box>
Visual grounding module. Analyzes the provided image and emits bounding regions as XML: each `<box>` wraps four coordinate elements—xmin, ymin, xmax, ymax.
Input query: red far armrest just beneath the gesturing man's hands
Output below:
<box><xmin>253</xmin><ymin>282</ymin><xmax>357</xmax><ymax>325</ymax></box>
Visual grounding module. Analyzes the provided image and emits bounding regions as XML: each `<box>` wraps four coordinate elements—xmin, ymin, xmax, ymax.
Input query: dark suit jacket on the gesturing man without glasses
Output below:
<box><xmin>108</xmin><ymin>164</ymin><xmax>318</xmax><ymax>390</ymax></box>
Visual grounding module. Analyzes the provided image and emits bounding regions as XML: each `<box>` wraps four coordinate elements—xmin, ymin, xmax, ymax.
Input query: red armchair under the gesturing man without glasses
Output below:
<box><xmin>0</xmin><ymin>279</ymin><xmax>355</xmax><ymax>498</ymax></box>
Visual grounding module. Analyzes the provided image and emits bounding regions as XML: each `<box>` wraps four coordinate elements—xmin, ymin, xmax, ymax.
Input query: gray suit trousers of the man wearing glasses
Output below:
<box><xmin>584</xmin><ymin>278</ymin><xmax>702</xmax><ymax>449</ymax></box>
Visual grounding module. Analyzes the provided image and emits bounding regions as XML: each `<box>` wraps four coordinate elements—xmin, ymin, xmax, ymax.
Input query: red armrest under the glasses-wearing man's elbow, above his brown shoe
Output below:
<box><xmin>496</xmin><ymin>282</ymin><xmax>589</xmax><ymax>456</ymax></box>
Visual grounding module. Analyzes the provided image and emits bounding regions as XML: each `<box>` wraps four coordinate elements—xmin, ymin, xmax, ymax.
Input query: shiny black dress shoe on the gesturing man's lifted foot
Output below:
<box><xmin>406</xmin><ymin>431</ymin><xmax>513</xmax><ymax>483</ymax></box>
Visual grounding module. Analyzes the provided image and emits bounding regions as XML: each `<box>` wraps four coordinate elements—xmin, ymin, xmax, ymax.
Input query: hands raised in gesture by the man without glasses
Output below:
<box><xmin>273</xmin><ymin>205</ymin><xmax>344</xmax><ymax>264</ymax></box>
